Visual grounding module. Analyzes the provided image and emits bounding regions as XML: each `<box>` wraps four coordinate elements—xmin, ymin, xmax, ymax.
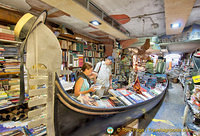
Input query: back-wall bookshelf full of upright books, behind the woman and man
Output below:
<box><xmin>58</xmin><ymin>34</ymin><xmax>105</xmax><ymax>69</ymax></box>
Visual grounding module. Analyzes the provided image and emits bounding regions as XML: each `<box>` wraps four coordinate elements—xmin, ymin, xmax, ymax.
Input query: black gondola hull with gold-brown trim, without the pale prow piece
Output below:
<box><xmin>54</xmin><ymin>78</ymin><xmax>167</xmax><ymax>136</ymax></box>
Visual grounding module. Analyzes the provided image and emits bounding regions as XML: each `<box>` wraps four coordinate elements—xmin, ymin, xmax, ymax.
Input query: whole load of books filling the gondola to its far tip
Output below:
<box><xmin>73</xmin><ymin>76</ymin><xmax>167</xmax><ymax>108</ymax></box>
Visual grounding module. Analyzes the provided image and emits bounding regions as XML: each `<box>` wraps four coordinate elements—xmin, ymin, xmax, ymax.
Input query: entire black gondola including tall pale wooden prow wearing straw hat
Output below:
<box><xmin>16</xmin><ymin>11</ymin><xmax>168</xmax><ymax>136</ymax></box>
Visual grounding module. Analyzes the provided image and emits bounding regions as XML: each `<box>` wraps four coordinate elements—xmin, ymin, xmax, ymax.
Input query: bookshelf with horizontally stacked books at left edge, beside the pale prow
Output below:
<box><xmin>0</xmin><ymin>19</ymin><xmax>46</xmax><ymax>135</ymax></box>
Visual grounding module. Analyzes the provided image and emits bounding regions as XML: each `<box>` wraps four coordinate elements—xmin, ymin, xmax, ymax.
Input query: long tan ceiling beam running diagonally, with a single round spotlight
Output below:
<box><xmin>41</xmin><ymin>0</ymin><xmax>129</xmax><ymax>39</ymax></box>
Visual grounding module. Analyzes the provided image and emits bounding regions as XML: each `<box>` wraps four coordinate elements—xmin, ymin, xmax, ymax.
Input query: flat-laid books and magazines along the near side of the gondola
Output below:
<box><xmin>74</xmin><ymin>84</ymin><xmax>165</xmax><ymax>108</ymax></box>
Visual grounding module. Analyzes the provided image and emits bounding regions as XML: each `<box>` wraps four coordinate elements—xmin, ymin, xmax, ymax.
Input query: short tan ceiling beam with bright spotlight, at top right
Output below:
<box><xmin>165</xmin><ymin>0</ymin><xmax>196</xmax><ymax>35</ymax></box>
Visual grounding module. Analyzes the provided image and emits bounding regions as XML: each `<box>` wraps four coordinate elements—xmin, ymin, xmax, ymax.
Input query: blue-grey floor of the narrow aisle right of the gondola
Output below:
<box><xmin>142</xmin><ymin>82</ymin><xmax>185</xmax><ymax>136</ymax></box>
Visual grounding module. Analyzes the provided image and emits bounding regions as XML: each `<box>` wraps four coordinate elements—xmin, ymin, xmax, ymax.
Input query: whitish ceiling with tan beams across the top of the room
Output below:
<box><xmin>0</xmin><ymin>0</ymin><xmax>200</xmax><ymax>53</ymax></box>
